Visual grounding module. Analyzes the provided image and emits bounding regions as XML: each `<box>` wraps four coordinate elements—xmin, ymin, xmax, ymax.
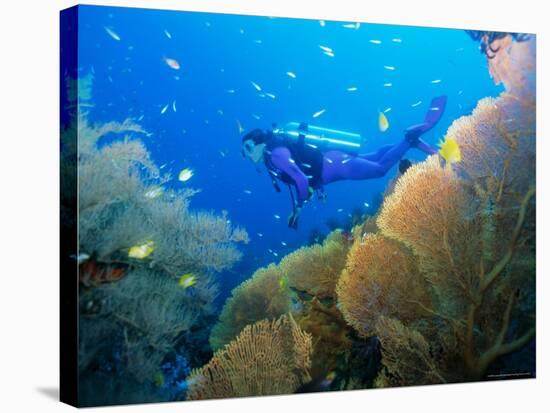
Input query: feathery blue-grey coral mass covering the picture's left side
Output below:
<box><xmin>68</xmin><ymin>80</ymin><xmax>248</xmax><ymax>405</ymax></box>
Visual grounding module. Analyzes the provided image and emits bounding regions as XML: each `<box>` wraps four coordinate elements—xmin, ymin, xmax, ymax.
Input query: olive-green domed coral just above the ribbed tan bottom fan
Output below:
<box><xmin>210</xmin><ymin>264</ymin><xmax>290</xmax><ymax>350</ymax></box>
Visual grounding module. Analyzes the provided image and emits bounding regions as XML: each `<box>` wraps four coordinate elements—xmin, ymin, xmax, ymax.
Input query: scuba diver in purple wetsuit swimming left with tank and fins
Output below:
<box><xmin>241</xmin><ymin>96</ymin><xmax>447</xmax><ymax>229</ymax></box>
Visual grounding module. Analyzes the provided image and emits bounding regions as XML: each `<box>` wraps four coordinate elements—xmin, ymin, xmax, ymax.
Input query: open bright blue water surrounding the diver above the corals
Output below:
<box><xmin>74</xmin><ymin>6</ymin><xmax>502</xmax><ymax>301</ymax></box>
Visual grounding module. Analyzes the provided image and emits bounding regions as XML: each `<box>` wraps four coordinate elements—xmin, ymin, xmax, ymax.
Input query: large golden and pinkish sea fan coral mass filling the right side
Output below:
<box><xmin>337</xmin><ymin>37</ymin><xmax>535</xmax><ymax>386</ymax></box>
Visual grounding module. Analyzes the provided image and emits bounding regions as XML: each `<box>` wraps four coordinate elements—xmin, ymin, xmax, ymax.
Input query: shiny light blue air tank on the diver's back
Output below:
<box><xmin>273</xmin><ymin>122</ymin><xmax>361</xmax><ymax>154</ymax></box>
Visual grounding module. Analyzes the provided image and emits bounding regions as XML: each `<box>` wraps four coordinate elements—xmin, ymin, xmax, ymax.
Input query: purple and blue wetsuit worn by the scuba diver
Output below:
<box><xmin>265</xmin><ymin>96</ymin><xmax>447</xmax><ymax>207</ymax></box>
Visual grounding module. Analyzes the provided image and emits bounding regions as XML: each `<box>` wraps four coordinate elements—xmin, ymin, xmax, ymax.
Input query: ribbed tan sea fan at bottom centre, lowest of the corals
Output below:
<box><xmin>187</xmin><ymin>314</ymin><xmax>312</xmax><ymax>400</ymax></box>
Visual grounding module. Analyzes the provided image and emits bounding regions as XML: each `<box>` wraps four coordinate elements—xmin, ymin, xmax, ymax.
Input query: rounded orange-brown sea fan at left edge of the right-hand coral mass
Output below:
<box><xmin>336</xmin><ymin>234</ymin><xmax>431</xmax><ymax>336</ymax></box>
